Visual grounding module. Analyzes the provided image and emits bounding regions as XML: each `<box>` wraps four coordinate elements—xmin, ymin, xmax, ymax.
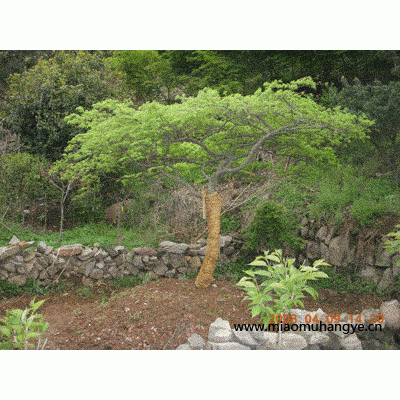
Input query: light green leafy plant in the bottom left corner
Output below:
<box><xmin>0</xmin><ymin>300</ymin><xmax>49</xmax><ymax>350</ymax></box>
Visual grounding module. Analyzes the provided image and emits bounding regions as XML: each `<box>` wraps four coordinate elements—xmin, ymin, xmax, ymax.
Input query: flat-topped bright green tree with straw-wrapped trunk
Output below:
<box><xmin>57</xmin><ymin>78</ymin><xmax>370</xmax><ymax>287</ymax></box>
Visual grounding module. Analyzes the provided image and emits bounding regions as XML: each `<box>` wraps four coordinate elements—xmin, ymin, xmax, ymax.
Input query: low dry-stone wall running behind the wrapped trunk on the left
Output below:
<box><xmin>0</xmin><ymin>236</ymin><xmax>241</xmax><ymax>285</ymax></box>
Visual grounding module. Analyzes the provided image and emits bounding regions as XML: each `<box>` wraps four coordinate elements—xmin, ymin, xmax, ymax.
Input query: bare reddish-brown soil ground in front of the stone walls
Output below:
<box><xmin>0</xmin><ymin>279</ymin><xmax>387</xmax><ymax>350</ymax></box>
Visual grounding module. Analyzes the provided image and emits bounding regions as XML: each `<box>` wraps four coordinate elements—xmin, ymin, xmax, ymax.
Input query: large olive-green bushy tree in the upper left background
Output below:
<box><xmin>6</xmin><ymin>51</ymin><xmax>120</xmax><ymax>161</ymax></box>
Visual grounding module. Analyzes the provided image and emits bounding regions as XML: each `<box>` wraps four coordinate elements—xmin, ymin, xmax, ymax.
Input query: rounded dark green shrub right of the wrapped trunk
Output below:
<box><xmin>244</xmin><ymin>201</ymin><xmax>302</xmax><ymax>251</ymax></box>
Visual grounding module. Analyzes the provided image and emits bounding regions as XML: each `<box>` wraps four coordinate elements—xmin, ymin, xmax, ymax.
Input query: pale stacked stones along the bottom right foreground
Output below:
<box><xmin>176</xmin><ymin>300</ymin><xmax>400</xmax><ymax>350</ymax></box>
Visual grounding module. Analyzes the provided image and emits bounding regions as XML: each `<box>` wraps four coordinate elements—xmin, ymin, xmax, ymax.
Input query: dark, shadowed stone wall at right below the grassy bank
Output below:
<box><xmin>299</xmin><ymin>218</ymin><xmax>400</xmax><ymax>290</ymax></box>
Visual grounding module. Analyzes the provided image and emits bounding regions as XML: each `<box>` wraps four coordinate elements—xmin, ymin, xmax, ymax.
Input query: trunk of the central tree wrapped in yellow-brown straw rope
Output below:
<box><xmin>195</xmin><ymin>192</ymin><xmax>221</xmax><ymax>288</ymax></box>
